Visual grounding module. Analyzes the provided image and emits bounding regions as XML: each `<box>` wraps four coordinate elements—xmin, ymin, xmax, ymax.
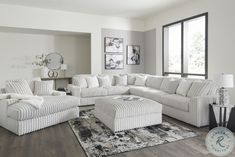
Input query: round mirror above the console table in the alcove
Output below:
<box><xmin>45</xmin><ymin>52</ymin><xmax>64</xmax><ymax>70</ymax></box>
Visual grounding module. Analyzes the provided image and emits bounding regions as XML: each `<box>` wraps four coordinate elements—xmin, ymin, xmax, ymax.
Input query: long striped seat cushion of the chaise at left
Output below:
<box><xmin>7</xmin><ymin>96</ymin><xmax>79</xmax><ymax>121</ymax></box>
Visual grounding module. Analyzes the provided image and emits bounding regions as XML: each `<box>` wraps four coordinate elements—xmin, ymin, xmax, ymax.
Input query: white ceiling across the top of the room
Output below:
<box><xmin>0</xmin><ymin>0</ymin><xmax>195</xmax><ymax>18</ymax></box>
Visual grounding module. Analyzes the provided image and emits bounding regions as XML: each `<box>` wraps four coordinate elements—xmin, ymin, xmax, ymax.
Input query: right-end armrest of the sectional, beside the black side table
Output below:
<box><xmin>189</xmin><ymin>96</ymin><xmax>214</xmax><ymax>127</ymax></box>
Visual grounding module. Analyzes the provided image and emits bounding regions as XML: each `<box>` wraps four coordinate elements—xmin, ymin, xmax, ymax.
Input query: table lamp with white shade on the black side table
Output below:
<box><xmin>215</xmin><ymin>73</ymin><xmax>233</xmax><ymax>105</ymax></box>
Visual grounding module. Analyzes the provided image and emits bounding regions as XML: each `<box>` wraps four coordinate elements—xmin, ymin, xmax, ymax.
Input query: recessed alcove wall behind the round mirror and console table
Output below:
<box><xmin>0</xmin><ymin>32</ymin><xmax>91</xmax><ymax>86</ymax></box>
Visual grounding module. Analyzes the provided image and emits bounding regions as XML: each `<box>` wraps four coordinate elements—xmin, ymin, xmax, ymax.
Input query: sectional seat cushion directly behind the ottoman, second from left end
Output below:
<box><xmin>105</xmin><ymin>86</ymin><xmax>129</xmax><ymax>95</ymax></box>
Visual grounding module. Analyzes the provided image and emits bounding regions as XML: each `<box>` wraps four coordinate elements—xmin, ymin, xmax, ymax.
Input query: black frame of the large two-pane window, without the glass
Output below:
<box><xmin>162</xmin><ymin>12</ymin><xmax>208</xmax><ymax>79</ymax></box>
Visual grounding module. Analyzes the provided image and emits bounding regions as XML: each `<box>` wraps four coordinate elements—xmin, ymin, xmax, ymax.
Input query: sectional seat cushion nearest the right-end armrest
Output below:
<box><xmin>162</xmin><ymin>94</ymin><xmax>190</xmax><ymax>112</ymax></box>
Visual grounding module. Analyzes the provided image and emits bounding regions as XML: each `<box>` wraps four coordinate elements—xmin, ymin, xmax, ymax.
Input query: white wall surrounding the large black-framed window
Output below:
<box><xmin>145</xmin><ymin>0</ymin><xmax>235</xmax><ymax>103</ymax></box>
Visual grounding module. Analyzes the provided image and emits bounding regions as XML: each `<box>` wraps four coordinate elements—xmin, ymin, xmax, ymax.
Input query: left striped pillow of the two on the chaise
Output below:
<box><xmin>6</xmin><ymin>80</ymin><xmax>33</xmax><ymax>95</ymax></box>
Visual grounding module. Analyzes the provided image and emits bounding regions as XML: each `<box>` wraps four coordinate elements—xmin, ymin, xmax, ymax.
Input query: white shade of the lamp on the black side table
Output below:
<box><xmin>214</xmin><ymin>74</ymin><xmax>234</xmax><ymax>88</ymax></box>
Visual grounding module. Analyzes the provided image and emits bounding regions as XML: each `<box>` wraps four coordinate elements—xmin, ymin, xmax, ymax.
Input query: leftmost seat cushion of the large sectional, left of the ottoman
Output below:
<box><xmin>81</xmin><ymin>87</ymin><xmax>108</xmax><ymax>98</ymax></box>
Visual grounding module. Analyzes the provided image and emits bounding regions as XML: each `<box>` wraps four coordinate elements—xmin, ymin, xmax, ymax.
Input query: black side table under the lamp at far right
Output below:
<box><xmin>209</xmin><ymin>104</ymin><xmax>235</xmax><ymax>132</ymax></box>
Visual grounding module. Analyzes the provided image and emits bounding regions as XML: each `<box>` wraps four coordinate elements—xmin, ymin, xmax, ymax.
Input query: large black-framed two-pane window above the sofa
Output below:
<box><xmin>162</xmin><ymin>13</ymin><xmax>208</xmax><ymax>79</ymax></box>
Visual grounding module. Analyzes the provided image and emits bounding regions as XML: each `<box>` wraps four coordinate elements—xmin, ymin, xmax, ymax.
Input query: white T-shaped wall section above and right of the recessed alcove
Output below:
<box><xmin>0</xmin><ymin>5</ymin><xmax>144</xmax><ymax>73</ymax></box>
